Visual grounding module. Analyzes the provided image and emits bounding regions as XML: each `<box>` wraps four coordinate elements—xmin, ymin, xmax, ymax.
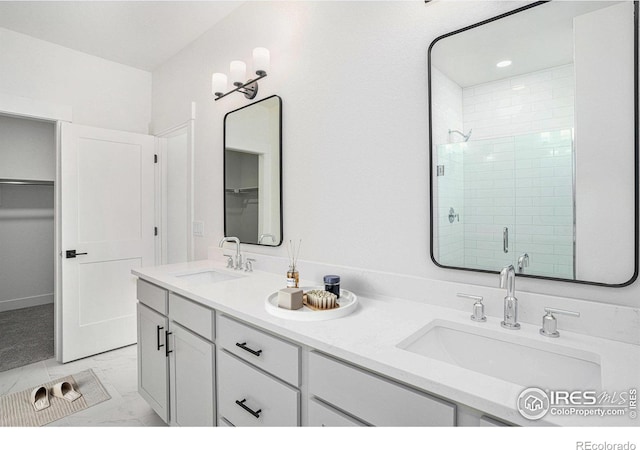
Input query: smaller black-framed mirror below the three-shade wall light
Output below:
<box><xmin>224</xmin><ymin>95</ymin><xmax>282</xmax><ymax>246</ymax></box>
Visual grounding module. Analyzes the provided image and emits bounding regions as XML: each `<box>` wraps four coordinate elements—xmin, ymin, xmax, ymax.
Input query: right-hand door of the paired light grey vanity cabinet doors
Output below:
<box><xmin>170</xmin><ymin>322</ymin><xmax>216</xmax><ymax>427</ymax></box>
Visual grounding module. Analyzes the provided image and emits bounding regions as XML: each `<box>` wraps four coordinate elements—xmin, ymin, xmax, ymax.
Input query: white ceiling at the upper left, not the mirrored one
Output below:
<box><xmin>0</xmin><ymin>0</ymin><xmax>244</xmax><ymax>71</ymax></box>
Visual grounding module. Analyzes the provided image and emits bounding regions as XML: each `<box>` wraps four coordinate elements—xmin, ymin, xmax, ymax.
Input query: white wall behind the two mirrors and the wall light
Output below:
<box><xmin>152</xmin><ymin>2</ymin><xmax>640</xmax><ymax>307</ymax></box>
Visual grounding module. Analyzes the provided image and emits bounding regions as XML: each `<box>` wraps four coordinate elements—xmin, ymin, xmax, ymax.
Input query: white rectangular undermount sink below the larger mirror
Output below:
<box><xmin>397</xmin><ymin>320</ymin><xmax>602</xmax><ymax>389</ymax></box>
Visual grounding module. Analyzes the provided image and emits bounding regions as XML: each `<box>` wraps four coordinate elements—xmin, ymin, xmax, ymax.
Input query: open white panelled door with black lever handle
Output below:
<box><xmin>59</xmin><ymin>123</ymin><xmax>154</xmax><ymax>362</ymax></box>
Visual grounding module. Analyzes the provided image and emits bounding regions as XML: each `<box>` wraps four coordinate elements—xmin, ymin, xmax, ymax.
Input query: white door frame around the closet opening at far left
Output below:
<box><xmin>0</xmin><ymin>94</ymin><xmax>73</xmax><ymax>362</ymax></box>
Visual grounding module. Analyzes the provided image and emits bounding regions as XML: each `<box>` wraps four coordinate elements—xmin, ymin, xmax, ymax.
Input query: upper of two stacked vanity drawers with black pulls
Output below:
<box><xmin>217</xmin><ymin>315</ymin><xmax>300</xmax><ymax>386</ymax></box>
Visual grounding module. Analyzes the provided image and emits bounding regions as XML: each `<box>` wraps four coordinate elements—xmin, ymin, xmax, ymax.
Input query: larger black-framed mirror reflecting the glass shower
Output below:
<box><xmin>428</xmin><ymin>1</ymin><xmax>638</xmax><ymax>286</ymax></box>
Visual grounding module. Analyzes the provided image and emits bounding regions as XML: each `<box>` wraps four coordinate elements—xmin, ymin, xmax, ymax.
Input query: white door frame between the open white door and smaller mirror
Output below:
<box><xmin>154</xmin><ymin>102</ymin><xmax>196</xmax><ymax>265</ymax></box>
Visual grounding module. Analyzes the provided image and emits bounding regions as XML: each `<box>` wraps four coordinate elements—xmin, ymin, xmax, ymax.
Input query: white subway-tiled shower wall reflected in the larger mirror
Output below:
<box><xmin>434</xmin><ymin>64</ymin><xmax>574</xmax><ymax>278</ymax></box>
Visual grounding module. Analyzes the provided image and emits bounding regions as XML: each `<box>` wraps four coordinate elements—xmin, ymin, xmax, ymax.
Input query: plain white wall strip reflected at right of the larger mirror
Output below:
<box><xmin>574</xmin><ymin>2</ymin><xmax>635</xmax><ymax>283</ymax></box>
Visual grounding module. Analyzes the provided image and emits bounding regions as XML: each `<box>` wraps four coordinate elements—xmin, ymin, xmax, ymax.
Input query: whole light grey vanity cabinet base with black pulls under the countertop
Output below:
<box><xmin>138</xmin><ymin>280</ymin><xmax>508</xmax><ymax>427</ymax></box>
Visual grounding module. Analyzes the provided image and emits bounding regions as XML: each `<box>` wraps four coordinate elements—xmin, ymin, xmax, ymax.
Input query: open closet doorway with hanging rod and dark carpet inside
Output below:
<box><xmin>0</xmin><ymin>115</ymin><xmax>56</xmax><ymax>372</ymax></box>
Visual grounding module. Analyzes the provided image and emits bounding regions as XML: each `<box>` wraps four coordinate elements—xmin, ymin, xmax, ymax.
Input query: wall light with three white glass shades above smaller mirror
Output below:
<box><xmin>211</xmin><ymin>47</ymin><xmax>269</xmax><ymax>101</ymax></box>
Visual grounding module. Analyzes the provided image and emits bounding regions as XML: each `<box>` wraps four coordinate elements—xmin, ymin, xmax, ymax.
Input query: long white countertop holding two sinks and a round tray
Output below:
<box><xmin>132</xmin><ymin>260</ymin><xmax>640</xmax><ymax>426</ymax></box>
